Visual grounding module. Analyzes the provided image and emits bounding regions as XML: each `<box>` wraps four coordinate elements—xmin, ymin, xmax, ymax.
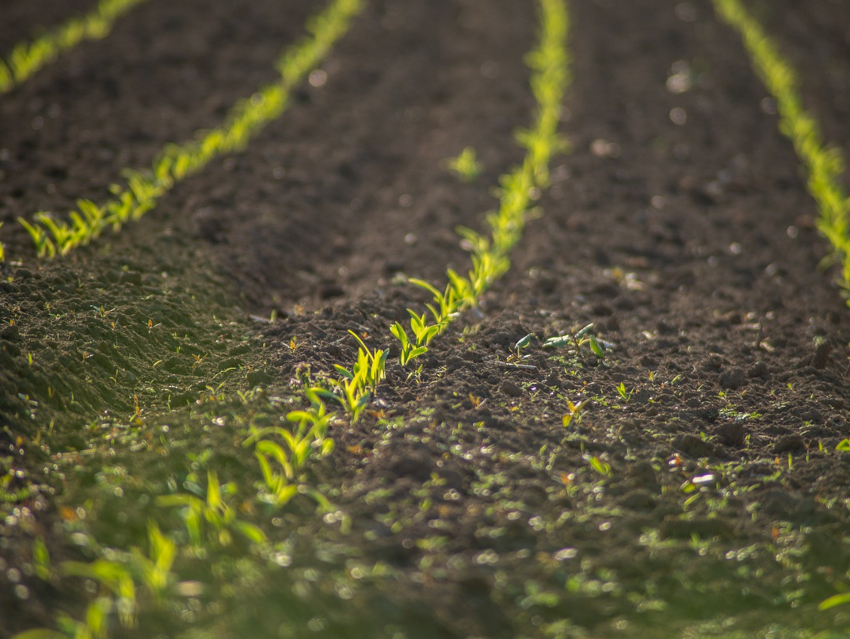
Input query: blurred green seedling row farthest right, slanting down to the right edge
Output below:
<box><xmin>714</xmin><ymin>0</ymin><xmax>850</xmax><ymax>305</ymax></box>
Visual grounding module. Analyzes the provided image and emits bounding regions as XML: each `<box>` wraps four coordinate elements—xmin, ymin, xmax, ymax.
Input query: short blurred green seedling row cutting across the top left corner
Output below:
<box><xmin>0</xmin><ymin>0</ymin><xmax>146</xmax><ymax>94</ymax></box>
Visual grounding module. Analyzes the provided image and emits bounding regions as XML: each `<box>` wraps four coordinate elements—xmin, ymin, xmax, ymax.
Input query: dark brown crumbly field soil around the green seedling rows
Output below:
<box><xmin>0</xmin><ymin>0</ymin><xmax>850</xmax><ymax>639</ymax></box>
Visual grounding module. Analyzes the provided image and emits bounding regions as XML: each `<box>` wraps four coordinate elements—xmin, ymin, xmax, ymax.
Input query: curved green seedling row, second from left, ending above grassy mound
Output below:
<box><xmin>13</xmin><ymin>0</ymin><xmax>363</xmax><ymax>258</ymax></box>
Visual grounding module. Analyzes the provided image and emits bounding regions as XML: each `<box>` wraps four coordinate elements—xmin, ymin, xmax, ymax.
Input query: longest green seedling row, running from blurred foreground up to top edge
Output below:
<box><xmin>6</xmin><ymin>0</ymin><xmax>570</xmax><ymax>639</ymax></box>
